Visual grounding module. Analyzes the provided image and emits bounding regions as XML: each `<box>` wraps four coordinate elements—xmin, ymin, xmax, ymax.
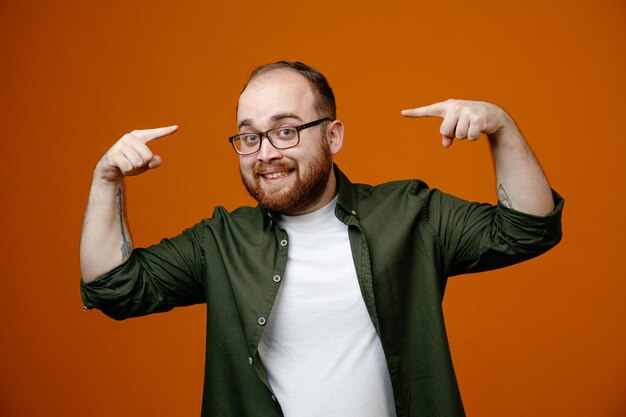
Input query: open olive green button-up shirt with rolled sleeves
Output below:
<box><xmin>81</xmin><ymin>167</ymin><xmax>563</xmax><ymax>417</ymax></box>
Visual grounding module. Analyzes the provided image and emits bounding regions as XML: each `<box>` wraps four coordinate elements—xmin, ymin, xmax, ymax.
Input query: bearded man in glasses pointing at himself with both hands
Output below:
<box><xmin>81</xmin><ymin>61</ymin><xmax>563</xmax><ymax>417</ymax></box>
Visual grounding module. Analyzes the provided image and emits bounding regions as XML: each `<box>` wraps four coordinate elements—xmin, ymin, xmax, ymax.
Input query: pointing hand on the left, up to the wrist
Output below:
<box><xmin>94</xmin><ymin>125</ymin><xmax>178</xmax><ymax>183</ymax></box>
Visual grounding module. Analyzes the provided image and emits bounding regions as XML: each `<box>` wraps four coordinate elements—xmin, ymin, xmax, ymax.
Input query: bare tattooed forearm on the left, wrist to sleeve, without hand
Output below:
<box><xmin>80</xmin><ymin>176</ymin><xmax>132</xmax><ymax>283</ymax></box>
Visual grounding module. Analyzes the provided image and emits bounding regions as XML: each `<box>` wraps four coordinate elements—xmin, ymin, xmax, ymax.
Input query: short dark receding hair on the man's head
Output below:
<box><xmin>242</xmin><ymin>61</ymin><xmax>337</xmax><ymax>120</ymax></box>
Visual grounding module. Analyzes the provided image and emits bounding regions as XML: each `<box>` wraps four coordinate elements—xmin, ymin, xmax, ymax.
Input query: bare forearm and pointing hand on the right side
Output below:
<box><xmin>402</xmin><ymin>100</ymin><xmax>554</xmax><ymax>216</ymax></box>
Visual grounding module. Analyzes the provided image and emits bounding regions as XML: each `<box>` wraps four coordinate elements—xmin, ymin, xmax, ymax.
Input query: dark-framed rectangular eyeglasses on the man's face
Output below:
<box><xmin>228</xmin><ymin>117</ymin><xmax>332</xmax><ymax>155</ymax></box>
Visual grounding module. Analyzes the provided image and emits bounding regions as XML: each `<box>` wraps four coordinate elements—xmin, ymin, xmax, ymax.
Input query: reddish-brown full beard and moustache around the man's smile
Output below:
<box><xmin>240</xmin><ymin>140</ymin><xmax>333</xmax><ymax>214</ymax></box>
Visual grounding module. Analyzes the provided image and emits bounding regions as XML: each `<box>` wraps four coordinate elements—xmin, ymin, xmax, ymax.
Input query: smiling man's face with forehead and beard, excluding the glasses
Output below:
<box><xmin>237</xmin><ymin>69</ymin><xmax>334</xmax><ymax>215</ymax></box>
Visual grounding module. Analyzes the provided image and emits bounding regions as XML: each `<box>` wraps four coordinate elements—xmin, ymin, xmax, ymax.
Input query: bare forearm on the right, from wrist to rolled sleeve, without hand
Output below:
<box><xmin>488</xmin><ymin>114</ymin><xmax>554</xmax><ymax>216</ymax></box>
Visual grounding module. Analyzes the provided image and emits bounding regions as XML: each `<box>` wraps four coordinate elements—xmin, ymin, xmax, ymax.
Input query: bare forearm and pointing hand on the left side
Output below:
<box><xmin>80</xmin><ymin>126</ymin><xmax>178</xmax><ymax>283</ymax></box>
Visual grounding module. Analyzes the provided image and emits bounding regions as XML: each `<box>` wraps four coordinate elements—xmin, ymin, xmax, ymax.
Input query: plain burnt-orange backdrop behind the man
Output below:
<box><xmin>0</xmin><ymin>0</ymin><xmax>626</xmax><ymax>417</ymax></box>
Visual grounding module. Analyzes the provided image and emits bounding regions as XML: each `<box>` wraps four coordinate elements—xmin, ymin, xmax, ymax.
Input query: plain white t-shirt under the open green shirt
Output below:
<box><xmin>259</xmin><ymin>198</ymin><xmax>395</xmax><ymax>417</ymax></box>
